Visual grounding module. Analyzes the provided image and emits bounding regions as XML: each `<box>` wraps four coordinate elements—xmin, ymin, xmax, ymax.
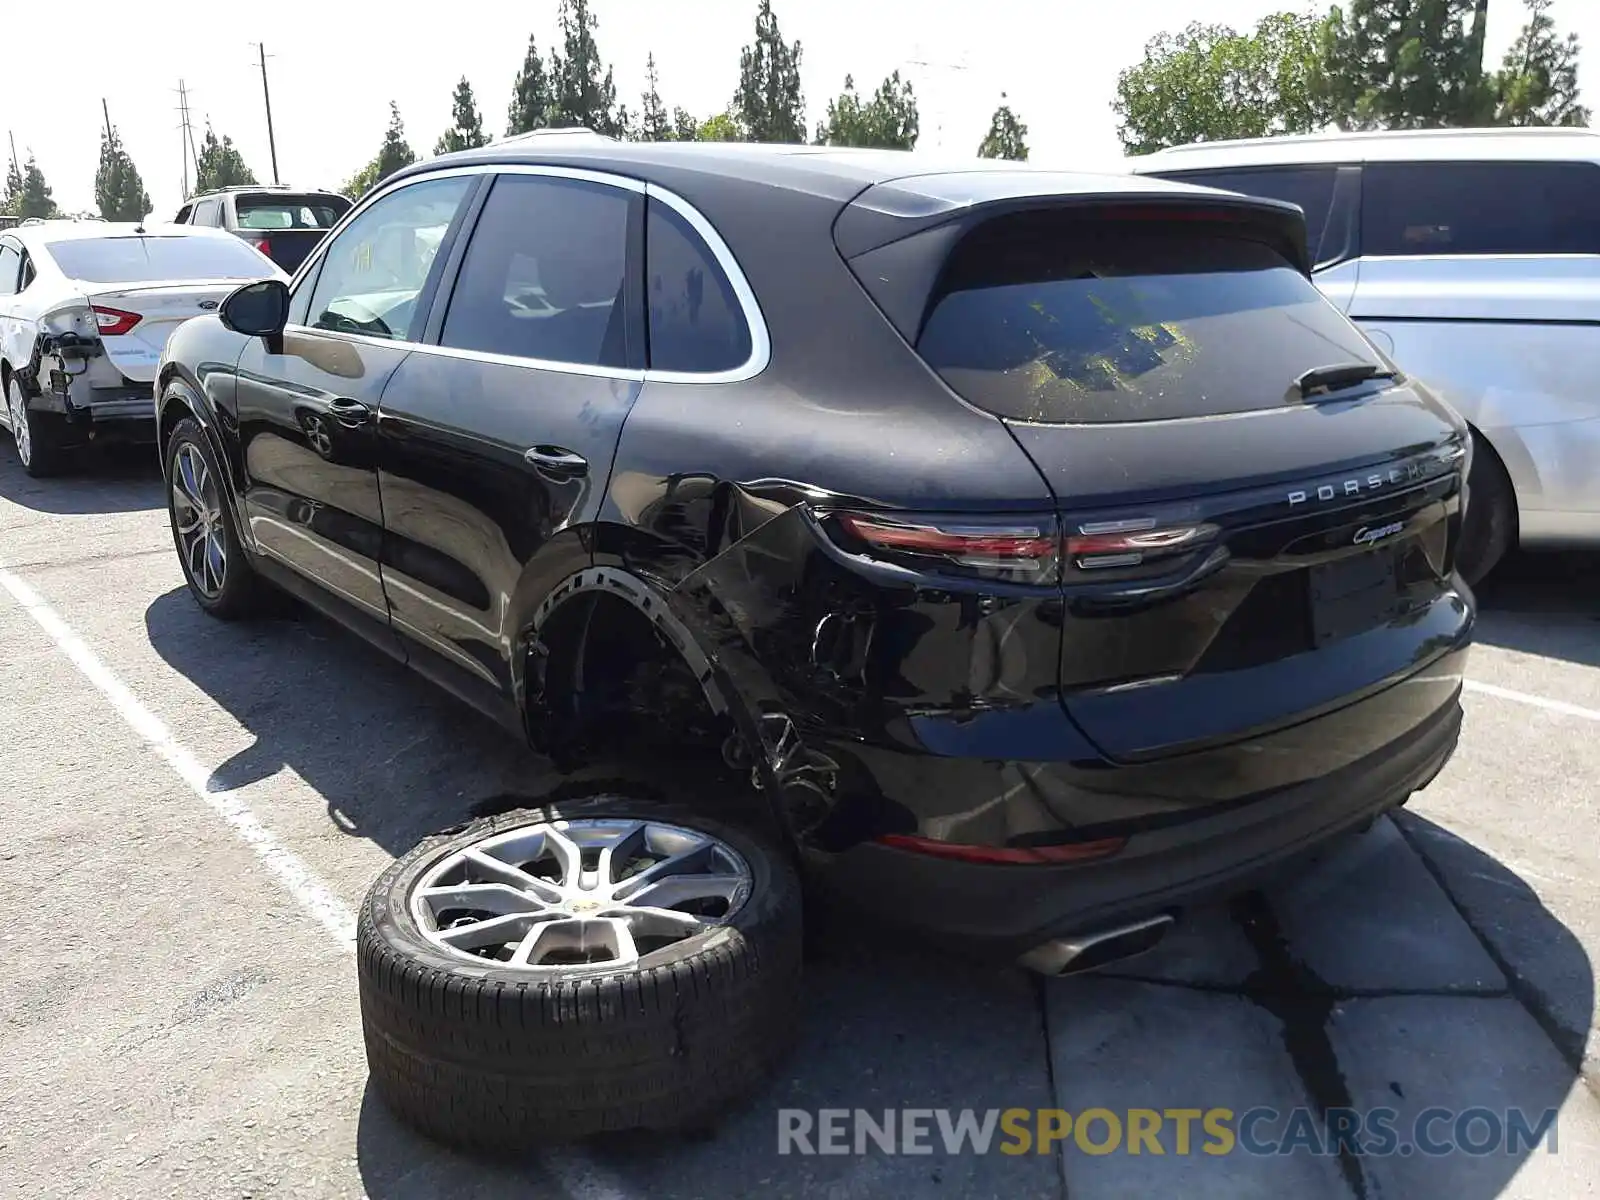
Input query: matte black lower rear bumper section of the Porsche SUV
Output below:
<box><xmin>808</xmin><ymin>651</ymin><xmax>1464</xmax><ymax>957</ymax></box>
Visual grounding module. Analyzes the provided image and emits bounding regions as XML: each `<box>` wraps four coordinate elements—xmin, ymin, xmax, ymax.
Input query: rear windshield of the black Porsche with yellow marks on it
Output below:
<box><xmin>917</xmin><ymin>214</ymin><xmax>1379</xmax><ymax>422</ymax></box>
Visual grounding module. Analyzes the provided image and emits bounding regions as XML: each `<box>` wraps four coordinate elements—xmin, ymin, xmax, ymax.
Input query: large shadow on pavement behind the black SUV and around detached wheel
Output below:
<box><xmin>357</xmin><ymin>814</ymin><xmax>1600</xmax><ymax>1200</ymax></box>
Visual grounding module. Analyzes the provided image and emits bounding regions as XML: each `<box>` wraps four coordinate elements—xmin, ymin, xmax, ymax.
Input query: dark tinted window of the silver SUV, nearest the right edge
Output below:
<box><xmin>1362</xmin><ymin>162</ymin><xmax>1600</xmax><ymax>254</ymax></box>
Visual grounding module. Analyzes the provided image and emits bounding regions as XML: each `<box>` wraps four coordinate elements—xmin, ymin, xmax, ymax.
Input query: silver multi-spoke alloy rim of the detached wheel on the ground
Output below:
<box><xmin>410</xmin><ymin>818</ymin><xmax>750</xmax><ymax>973</ymax></box>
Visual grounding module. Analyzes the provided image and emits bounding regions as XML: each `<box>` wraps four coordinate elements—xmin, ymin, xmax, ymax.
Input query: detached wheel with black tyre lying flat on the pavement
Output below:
<box><xmin>357</xmin><ymin>795</ymin><xmax>802</xmax><ymax>1154</ymax></box>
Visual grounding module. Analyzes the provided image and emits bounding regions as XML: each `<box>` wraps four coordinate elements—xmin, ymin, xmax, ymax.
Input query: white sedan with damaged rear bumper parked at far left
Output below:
<box><xmin>0</xmin><ymin>221</ymin><xmax>288</xmax><ymax>475</ymax></box>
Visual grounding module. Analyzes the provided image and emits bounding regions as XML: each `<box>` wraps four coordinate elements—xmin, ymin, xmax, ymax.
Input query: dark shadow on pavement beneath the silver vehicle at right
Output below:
<box><xmin>1475</xmin><ymin>550</ymin><xmax>1600</xmax><ymax>667</ymax></box>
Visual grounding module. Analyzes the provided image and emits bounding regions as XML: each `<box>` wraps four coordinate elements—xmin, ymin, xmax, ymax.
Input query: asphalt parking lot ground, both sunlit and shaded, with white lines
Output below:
<box><xmin>0</xmin><ymin>448</ymin><xmax>1600</xmax><ymax>1200</ymax></box>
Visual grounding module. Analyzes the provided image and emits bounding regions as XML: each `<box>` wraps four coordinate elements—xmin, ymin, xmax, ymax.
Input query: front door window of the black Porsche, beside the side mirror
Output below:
<box><xmin>302</xmin><ymin>176</ymin><xmax>474</xmax><ymax>341</ymax></box>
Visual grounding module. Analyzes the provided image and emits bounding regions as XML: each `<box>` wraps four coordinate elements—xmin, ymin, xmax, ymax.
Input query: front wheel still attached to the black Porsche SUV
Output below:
<box><xmin>165</xmin><ymin>418</ymin><xmax>267</xmax><ymax>621</ymax></box>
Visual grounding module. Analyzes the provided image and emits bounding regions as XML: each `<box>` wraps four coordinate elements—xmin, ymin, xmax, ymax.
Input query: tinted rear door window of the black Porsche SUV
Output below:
<box><xmin>440</xmin><ymin>174</ymin><xmax>634</xmax><ymax>366</ymax></box>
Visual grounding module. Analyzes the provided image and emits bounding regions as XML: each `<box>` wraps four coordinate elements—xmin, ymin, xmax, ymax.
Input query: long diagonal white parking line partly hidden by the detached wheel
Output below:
<box><xmin>0</xmin><ymin>563</ymin><xmax>630</xmax><ymax>1200</ymax></box>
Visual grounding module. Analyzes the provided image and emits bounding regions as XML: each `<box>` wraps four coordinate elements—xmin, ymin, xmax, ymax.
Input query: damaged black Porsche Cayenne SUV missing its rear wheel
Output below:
<box><xmin>157</xmin><ymin>138</ymin><xmax>1474</xmax><ymax>970</ymax></box>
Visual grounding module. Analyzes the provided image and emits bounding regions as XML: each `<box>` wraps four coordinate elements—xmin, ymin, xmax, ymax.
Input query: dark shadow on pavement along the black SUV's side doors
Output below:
<box><xmin>144</xmin><ymin>587</ymin><xmax>550</xmax><ymax>858</ymax></box>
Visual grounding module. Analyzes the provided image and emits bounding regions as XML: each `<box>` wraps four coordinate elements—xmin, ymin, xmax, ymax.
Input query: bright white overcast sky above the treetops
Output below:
<box><xmin>0</xmin><ymin>0</ymin><xmax>1600</xmax><ymax>218</ymax></box>
